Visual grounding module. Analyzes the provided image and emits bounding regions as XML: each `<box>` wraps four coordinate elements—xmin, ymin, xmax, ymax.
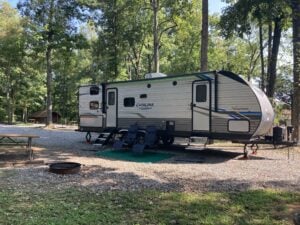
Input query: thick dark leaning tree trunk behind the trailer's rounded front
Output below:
<box><xmin>267</xmin><ymin>18</ymin><xmax>282</xmax><ymax>98</ymax></box>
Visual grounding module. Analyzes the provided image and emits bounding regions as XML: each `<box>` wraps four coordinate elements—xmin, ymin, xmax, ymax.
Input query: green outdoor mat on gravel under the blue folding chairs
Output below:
<box><xmin>96</xmin><ymin>149</ymin><xmax>174</xmax><ymax>163</ymax></box>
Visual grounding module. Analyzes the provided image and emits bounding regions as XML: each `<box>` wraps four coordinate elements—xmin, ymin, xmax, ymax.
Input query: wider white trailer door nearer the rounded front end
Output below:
<box><xmin>192</xmin><ymin>81</ymin><xmax>212</xmax><ymax>132</ymax></box>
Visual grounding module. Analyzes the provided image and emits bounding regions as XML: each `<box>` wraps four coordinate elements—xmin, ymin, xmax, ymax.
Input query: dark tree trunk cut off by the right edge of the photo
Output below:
<box><xmin>291</xmin><ymin>0</ymin><xmax>300</xmax><ymax>144</ymax></box>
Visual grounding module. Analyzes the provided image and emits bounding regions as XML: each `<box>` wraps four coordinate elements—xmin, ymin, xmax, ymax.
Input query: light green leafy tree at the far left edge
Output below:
<box><xmin>0</xmin><ymin>2</ymin><xmax>25</xmax><ymax>124</ymax></box>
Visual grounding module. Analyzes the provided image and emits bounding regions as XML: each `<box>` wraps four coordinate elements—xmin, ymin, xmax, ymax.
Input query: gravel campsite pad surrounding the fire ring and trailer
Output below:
<box><xmin>0</xmin><ymin>125</ymin><xmax>300</xmax><ymax>192</ymax></box>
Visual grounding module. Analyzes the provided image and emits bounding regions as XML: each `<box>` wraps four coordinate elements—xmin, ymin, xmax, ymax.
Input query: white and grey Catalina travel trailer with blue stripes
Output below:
<box><xmin>79</xmin><ymin>71</ymin><xmax>274</xmax><ymax>147</ymax></box>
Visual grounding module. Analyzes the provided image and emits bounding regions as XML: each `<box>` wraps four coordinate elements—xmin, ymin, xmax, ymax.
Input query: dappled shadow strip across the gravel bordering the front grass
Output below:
<box><xmin>0</xmin><ymin>165</ymin><xmax>300</xmax><ymax>192</ymax></box>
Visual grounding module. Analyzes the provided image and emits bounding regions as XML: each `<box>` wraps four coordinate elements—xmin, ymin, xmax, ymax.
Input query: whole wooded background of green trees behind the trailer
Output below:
<box><xmin>0</xmin><ymin>0</ymin><xmax>300</xmax><ymax>140</ymax></box>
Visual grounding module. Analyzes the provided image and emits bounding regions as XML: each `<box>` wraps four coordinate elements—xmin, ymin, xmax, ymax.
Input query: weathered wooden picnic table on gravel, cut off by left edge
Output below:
<box><xmin>0</xmin><ymin>133</ymin><xmax>39</xmax><ymax>161</ymax></box>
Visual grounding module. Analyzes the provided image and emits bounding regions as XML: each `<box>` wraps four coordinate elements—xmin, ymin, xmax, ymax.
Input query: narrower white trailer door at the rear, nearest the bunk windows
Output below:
<box><xmin>106</xmin><ymin>88</ymin><xmax>118</xmax><ymax>127</ymax></box>
